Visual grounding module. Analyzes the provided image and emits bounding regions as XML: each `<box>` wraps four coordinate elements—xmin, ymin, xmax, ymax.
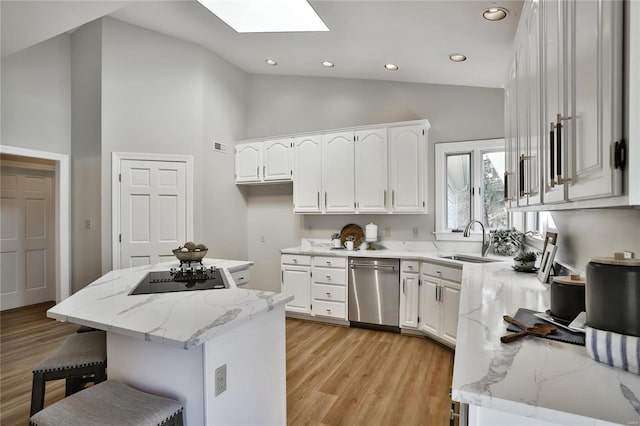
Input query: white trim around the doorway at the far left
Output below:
<box><xmin>0</xmin><ymin>145</ymin><xmax>71</xmax><ymax>303</ymax></box>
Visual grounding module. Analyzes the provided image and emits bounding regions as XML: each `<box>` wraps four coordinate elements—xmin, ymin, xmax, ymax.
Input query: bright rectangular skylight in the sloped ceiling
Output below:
<box><xmin>198</xmin><ymin>0</ymin><xmax>329</xmax><ymax>33</ymax></box>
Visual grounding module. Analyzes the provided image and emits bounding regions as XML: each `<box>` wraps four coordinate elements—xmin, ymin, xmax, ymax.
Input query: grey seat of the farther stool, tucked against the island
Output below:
<box><xmin>33</xmin><ymin>331</ymin><xmax>107</xmax><ymax>373</ymax></box>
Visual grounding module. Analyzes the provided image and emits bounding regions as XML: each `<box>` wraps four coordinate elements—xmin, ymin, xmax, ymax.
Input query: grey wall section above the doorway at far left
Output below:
<box><xmin>1</xmin><ymin>34</ymin><xmax>71</xmax><ymax>154</ymax></box>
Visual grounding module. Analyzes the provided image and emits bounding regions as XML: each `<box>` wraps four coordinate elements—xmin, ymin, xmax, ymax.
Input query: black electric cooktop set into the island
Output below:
<box><xmin>129</xmin><ymin>268</ymin><xmax>229</xmax><ymax>295</ymax></box>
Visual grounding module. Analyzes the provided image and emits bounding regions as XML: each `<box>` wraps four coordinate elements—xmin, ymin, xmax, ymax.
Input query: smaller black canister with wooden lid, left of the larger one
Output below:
<box><xmin>550</xmin><ymin>275</ymin><xmax>585</xmax><ymax>321</ymax></box>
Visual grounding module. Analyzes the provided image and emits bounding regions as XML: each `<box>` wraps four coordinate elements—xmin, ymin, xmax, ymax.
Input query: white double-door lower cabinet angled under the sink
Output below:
<box><xmin>419</xmin><ymin>262</ymin><xmax>462</xmax><ymax>346</ymax></box>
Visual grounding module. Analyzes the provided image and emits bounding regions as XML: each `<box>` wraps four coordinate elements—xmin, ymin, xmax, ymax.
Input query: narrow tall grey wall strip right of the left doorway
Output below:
<box><xmin>71</xmin><ymin>20</ymin><xmax>102</xmax><ymax>292</ymax></box>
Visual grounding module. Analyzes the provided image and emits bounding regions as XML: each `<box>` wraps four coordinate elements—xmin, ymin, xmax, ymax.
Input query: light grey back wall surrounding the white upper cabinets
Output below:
<box><xmin>248</xmin><ymin>75</ymin><xmax>504</xmax><ymax>290</ymax></box>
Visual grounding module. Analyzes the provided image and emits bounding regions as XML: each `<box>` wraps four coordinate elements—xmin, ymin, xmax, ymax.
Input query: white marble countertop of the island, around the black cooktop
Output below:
<box><xmin>47</xmin><ymin>258</ymin><xmax>293</xmax><ymax>349</ymax></box>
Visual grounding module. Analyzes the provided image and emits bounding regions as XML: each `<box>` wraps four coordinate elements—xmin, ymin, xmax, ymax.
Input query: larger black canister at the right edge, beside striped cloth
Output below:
<box><xmin>586</xmin><ymin>257</ymin><xmax>640</xmax><ymax>337</ymax></box>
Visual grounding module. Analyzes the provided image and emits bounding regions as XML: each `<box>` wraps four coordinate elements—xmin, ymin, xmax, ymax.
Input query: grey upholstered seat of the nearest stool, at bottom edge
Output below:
<box><xmin>30</xmin><ymin>380</ymin><xmax>183</xmax><ymax>426</ymax></box>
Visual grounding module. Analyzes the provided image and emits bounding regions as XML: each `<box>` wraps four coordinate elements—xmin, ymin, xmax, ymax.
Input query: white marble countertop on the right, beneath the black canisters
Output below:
<box><xmin>453</xmin><ymin>264</ymin><xmax>640</xmax><ymax>425</ymax></box>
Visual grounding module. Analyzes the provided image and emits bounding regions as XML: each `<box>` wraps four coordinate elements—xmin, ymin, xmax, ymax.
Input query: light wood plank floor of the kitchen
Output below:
<box><xmin>0</xmin><ymin>303</ymin><xmax>453</xmax><ymax>426</ymax></box>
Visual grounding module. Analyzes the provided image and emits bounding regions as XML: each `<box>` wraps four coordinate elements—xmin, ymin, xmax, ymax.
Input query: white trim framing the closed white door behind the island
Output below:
<box><xmin>111</xmin><ymin>152</ymin><xmax>194</xmax><ymax>269</ymax></box>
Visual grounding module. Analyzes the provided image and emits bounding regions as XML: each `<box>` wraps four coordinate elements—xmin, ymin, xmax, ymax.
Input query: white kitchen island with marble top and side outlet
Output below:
<box><xmin>47</xmin><ymin>259</ymin><xmax>291</xmax><ymax>425</ymax></box>
